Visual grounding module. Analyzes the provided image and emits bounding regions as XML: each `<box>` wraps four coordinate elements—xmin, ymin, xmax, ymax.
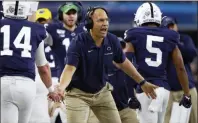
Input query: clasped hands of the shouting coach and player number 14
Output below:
<box><xmin>48</xmin><ymin>85</ymin><xmax>64</xmax><ymax>102</ymax></box>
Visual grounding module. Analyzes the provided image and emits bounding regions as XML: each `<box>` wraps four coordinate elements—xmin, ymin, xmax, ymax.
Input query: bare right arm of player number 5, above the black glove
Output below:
<box><xmin>172</xmin><ymin>46</ymin><xmax>190</xmax><ymax>96</ymax></box>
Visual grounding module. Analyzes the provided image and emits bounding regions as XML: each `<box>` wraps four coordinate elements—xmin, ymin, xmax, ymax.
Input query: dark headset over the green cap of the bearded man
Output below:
<box><xmin>58</xmin><ymin>2</ymin><xmax>83</xmax><ymax>23</ymax></box>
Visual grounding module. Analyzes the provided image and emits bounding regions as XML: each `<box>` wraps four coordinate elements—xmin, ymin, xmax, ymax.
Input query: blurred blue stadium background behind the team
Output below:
<box><xmin>0</xmin><ymin>1</ymin><xmax>198</xmax><ymax>88</ymax></box>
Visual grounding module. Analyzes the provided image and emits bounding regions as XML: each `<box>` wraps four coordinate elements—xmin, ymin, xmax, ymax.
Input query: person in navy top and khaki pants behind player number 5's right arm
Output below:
<box><xmin>161</xmin><ymin>16</ymin><xmax>197</xmax><ymax>123</ymax></box>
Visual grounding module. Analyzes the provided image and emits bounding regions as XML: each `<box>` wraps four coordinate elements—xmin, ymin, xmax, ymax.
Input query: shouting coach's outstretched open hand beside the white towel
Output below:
<box><xmin>141</xmin><ymin>82</ymin><xmax>158</xmax><ymax>99</ymax></box>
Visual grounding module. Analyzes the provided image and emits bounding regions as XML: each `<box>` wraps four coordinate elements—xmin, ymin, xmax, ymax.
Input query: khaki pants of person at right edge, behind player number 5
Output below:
<box><xmin>164</xmin><ymin>88</ymin><xmax>197</xmax><ymax>123</ymax></box>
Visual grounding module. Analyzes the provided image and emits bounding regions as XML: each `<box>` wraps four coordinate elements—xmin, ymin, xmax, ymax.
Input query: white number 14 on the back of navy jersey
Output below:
<box><xmin>0</xmin><ymin>25</ymin><xmax>32</xmax><ymax>58</ymax></box>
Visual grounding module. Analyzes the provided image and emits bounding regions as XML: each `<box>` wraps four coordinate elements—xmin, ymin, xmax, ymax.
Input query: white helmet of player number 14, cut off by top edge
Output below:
<box><xmin>3</xmin><ymin>1</ymin><xmax>30</xmax><ymax>19</ymax></box>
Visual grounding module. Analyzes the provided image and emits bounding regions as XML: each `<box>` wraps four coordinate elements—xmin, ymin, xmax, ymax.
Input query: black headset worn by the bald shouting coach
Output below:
<box><xmin>85</xmin><ymin>6</ymin><xmax>109</xmax><ymax>30</ymax></box>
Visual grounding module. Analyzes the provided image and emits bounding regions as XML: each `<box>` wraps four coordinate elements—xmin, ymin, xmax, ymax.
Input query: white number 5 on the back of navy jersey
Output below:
<box><xmin>145</xmin><ymin>35</ymin><xmax>164</xmax><ymax>67</ymax></box>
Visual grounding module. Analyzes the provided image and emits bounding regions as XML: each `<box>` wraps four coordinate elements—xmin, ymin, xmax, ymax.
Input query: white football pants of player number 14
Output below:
<box><xmin>0</xmin><ymin>76</ymin><xmax>36</xmax><ymax>123</ymax></box>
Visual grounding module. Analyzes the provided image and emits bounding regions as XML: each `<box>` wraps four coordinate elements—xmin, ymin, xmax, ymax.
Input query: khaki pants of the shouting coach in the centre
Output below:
<box><xmin>64</xmin><ymin>83</ymin><xmax>121</xmax><ymax>123</ymax></box>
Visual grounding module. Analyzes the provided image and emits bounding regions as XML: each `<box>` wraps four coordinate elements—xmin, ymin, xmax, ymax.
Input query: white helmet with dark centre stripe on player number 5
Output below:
<box><xmin>134</xmin><ymin>2</ymin><xmax>162</xmax><ymax>26</ymax></box>
